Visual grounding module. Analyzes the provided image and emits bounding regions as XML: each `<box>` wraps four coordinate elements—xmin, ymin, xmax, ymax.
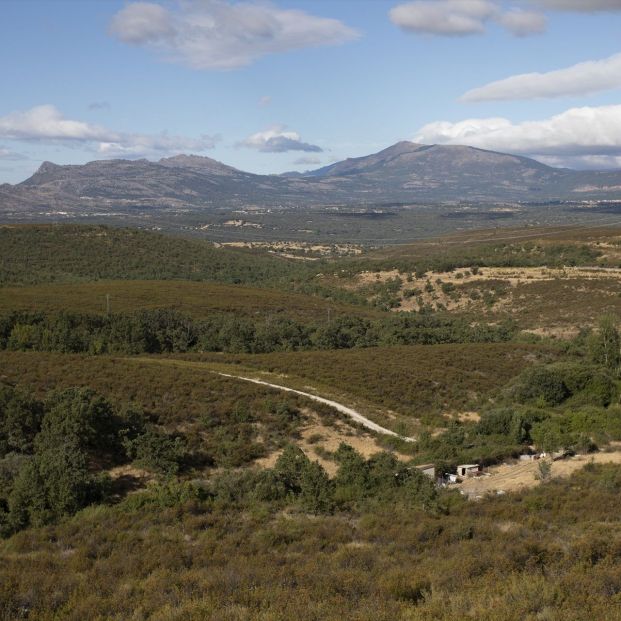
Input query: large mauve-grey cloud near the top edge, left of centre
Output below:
<box><xmin>110</xmin><ymin>0</ymin><xmax>359</xmax><ymax>70</ymax></box>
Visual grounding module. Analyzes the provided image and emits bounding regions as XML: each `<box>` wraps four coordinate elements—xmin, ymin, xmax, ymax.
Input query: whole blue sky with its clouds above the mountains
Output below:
<box><xmin>0</xmin><ymin>0</ymin><xmax>621</xmax><ymax>183</ymax></box>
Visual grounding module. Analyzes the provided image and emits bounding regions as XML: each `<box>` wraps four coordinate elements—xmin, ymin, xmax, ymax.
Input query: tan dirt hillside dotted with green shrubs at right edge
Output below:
<box><xmin>345</xmin><ymin>267</ymin><xmax>621</xmax><ymax>330</ymax></box>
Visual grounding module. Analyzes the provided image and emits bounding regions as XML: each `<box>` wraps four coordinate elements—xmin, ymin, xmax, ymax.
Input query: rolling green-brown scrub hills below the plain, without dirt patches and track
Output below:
<box><xmin>0</xmin><ymin>226</ymin><xmax>621</xmax><ymax>621</ymax></box>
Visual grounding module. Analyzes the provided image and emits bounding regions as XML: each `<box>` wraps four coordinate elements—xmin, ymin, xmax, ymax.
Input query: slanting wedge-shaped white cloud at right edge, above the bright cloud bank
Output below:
<box><xmin>461</xmin><ymin>54</ymin><xmax>621</xmax><ymax>101</ymax></box>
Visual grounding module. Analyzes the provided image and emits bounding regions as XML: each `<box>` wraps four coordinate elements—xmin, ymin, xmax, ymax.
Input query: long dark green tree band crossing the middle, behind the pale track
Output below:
<box><xmin>0</xmin><ymin>309</ymin><xmax>516</xmax><ymax>354</ymax></box>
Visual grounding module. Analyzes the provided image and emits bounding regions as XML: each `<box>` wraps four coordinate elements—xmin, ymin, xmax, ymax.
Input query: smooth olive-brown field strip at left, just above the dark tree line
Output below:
<box><xmin>0</xmin><ymin>280</ymin><xmax>378</xmax><ymax>320</ymax></box>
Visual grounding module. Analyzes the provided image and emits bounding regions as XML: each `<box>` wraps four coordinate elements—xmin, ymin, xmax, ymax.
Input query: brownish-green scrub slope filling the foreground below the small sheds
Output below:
<box><xmin>0</xmin><ymin>458</ymin><xmax>621</xmax><ymax>621</ymax></box>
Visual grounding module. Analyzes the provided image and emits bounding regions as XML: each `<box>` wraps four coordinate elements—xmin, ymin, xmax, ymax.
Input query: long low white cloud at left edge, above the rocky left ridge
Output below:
<box><xmin>0</xmin><ymin>104</ymin><xmax>216</xmax><ymax>157</ymax></box>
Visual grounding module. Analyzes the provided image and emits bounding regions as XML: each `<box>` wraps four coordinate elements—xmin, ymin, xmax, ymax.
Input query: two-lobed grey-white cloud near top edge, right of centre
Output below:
<box><xmin>389</xmin><ymin>0</ymin><xmax>546</xmax><ymax>37</ymax></box>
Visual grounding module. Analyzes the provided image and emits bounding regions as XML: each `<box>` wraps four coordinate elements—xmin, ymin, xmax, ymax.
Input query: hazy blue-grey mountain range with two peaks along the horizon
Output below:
<box><xmin>0</xmin><ymin>142</ymin><xmax>621</xmax><ymax>215</ymax></box>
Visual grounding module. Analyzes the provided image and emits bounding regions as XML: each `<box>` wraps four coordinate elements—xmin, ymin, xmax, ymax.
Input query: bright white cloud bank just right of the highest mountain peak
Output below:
<box><xmin>414</xmin><ymin>105</ymin><xmax>621</xmax><ymax>167</ymax></box>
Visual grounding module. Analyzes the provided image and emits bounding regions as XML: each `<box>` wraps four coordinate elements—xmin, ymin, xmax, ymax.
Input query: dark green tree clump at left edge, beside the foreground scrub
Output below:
<box><xmin>0</xmin><ymin>385</ymin><xmax>184</xmax><ymax>534</ymax></box>
